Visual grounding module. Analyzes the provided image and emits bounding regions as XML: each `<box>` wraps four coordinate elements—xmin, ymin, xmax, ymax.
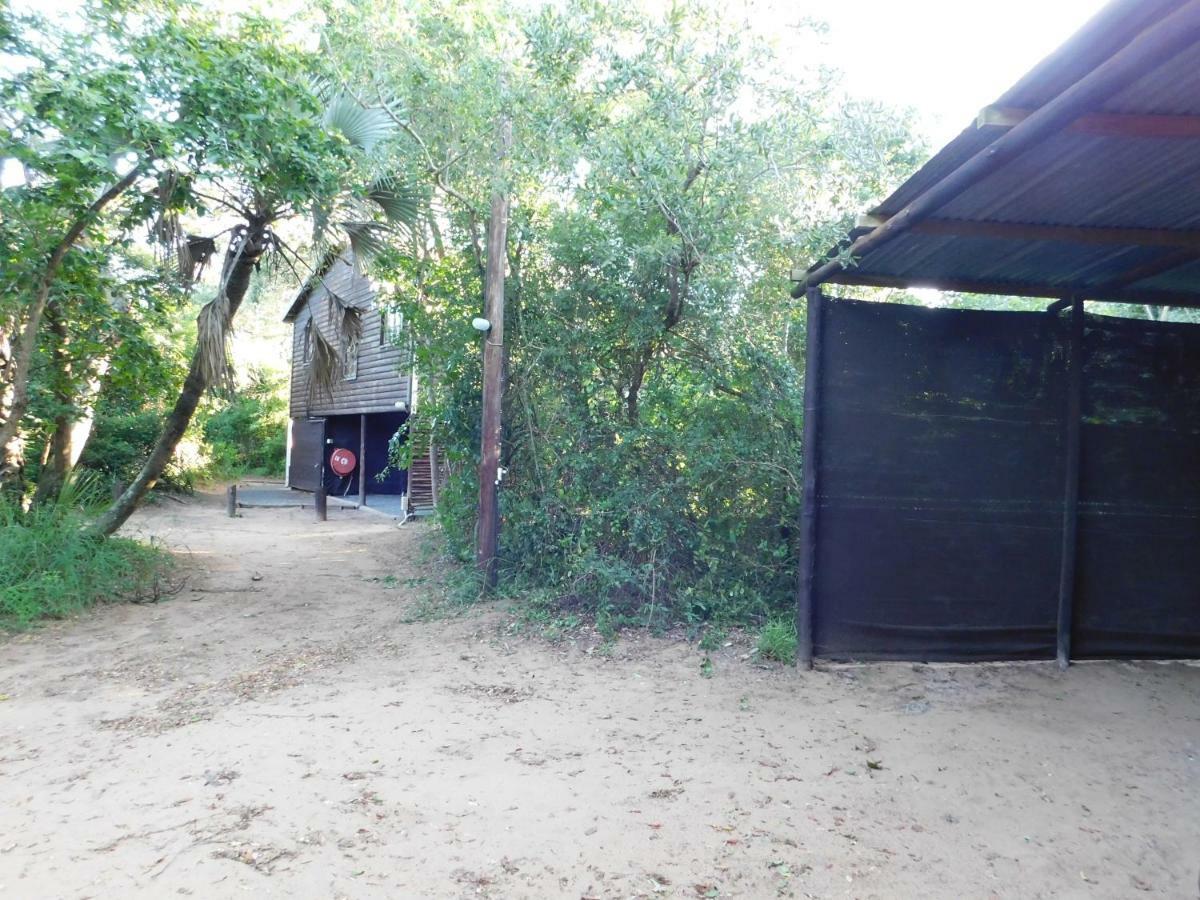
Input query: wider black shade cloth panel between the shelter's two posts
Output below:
<box><xmin>814</xmin><ymin>300</ymin><xmax>1064</xmax><ymax>660</ymax></box>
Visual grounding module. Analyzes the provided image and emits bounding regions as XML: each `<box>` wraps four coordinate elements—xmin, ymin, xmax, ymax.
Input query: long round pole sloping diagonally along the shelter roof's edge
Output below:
<box><xmin>792</xmin><ymin>0</ymin><xmax>1200</xmax><ymax>303</ymax></box>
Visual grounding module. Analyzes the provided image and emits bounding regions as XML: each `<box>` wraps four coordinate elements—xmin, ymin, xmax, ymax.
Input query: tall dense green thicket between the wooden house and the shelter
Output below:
<box><xmin>328</xmin><ymin>0</ymin><xmax>917</xmax><ymax>634</ymax></box>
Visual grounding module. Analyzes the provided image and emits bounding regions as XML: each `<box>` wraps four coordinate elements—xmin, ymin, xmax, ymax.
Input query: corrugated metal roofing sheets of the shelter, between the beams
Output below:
<box><xmin>810</xmin><ymin>0</ymin><xmax>1200</xmax><ymax>307</ymax></box>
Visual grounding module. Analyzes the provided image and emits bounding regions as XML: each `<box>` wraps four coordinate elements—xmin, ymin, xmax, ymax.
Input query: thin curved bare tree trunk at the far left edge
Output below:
<box><xmin>0</xmin><ymin>168</ymin><xmax>142</xmax><ymax>488</ymax></box>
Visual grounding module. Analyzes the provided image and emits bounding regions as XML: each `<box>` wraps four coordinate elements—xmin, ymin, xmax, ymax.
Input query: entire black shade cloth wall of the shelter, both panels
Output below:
<box><xmin>814</xmin><ymin>300</ymin><xmax>1200</xmax><ymax>660</ymax></box>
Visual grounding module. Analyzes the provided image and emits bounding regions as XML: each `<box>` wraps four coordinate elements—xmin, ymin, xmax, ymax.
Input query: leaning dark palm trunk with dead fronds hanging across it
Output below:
<box><xmin>94</xmin><ymin>222</ymin><xmax>266</xmax><ymax>536</ymax></box>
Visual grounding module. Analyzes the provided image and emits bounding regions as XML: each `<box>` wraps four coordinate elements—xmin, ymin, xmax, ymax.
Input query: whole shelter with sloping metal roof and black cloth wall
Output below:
<box><xmin>794</xmin><ymin>0</ymin><xmax>1200</xmax><ymax>666</ymax></box>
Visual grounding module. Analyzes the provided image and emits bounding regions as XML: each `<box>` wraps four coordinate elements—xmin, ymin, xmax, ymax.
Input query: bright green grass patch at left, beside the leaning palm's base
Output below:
<box><xmin>0</xmin><ymin>475</ymin><xmax>169</xmax><ymax>630</ymax></box>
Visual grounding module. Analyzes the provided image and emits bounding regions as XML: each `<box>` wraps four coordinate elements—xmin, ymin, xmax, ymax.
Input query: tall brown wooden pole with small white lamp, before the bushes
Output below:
<box><xmin>475</xmin><ymin>115</ymin><xmax>512</xmax><ymax>590</ymax></box>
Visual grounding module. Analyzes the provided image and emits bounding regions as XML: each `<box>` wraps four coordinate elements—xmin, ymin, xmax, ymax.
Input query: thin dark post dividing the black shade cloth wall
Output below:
<box><xmin>1056</xmin><ymin>296</ymin><xmax>1084</xmax><ymax>671</ymax></box>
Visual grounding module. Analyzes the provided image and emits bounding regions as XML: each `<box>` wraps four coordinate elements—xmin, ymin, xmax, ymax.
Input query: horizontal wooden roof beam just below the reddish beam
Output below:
<box><xmin>854</xmin><ymin>215</ymin><xmax>1200</xmax><ymax>252</ymax></box>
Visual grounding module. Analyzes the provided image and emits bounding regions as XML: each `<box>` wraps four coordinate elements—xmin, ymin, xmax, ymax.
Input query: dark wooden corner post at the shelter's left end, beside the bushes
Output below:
<box><xmin>796</xmin><ymin>288</ymin><xmax>826</xmax><ymax>668</ymax></box>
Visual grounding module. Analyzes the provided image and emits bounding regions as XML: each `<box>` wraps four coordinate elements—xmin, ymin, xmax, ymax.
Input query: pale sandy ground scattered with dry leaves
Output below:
<box><xmin>0</xmin><ymin>497</ymin><xmax>1200</xmax><ymax>900</ymax></box>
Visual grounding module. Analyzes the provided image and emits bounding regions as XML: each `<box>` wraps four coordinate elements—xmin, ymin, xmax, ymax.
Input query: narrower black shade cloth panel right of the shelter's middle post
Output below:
<box><xmin>1072</xmin><ymin>316</ymin><xmax>1200</xmax><ymax>658</ymax></box>
